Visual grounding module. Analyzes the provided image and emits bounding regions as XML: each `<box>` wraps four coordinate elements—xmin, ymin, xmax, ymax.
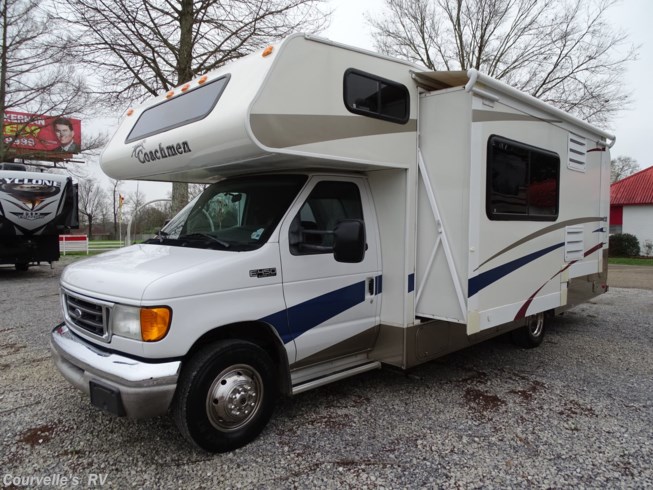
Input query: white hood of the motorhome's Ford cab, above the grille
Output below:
<box><xmin>61</xmin><ymin>242</ymin><xmax>280</xmax><ymax>304</ymax></box>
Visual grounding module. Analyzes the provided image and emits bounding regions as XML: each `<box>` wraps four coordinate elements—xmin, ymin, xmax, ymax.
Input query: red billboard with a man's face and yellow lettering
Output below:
<box><xmin>2</xmin><ymin>111</ymin><xmax>82</xmax><ymax>156</ymax></box>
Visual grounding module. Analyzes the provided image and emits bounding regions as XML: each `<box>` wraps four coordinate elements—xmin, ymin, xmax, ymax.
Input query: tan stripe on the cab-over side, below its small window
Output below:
<box><xmin>250</xmin><ymin>114</ymin><xmax>417</xmax><ymax>148</ymax></box>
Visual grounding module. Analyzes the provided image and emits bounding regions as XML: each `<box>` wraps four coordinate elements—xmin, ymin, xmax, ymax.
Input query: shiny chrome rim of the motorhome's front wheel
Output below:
<box><xmin>206</xmin><ymin>364</ymin><xmax>263</xmax><ymax>432</ymax></box>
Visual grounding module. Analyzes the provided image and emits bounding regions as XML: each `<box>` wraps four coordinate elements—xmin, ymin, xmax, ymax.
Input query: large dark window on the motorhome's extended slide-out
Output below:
<box><xmin>486</xmin><ymin>135</ymin><xmax>560</xmax><ymax>221</ymax></box>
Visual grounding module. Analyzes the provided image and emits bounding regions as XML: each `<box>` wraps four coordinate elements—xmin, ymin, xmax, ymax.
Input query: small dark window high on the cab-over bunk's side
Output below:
<box><xmin>344</xmin><ymin>69</ymin><xmax>410</xmax><ymax>124</ymax></box>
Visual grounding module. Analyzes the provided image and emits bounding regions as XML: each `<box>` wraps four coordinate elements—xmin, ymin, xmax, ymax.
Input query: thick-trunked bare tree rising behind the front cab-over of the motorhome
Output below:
<box><xmin>60</xmin><ymin>0</ymin><xmax>327</xmax><ymax>211</ymax></box>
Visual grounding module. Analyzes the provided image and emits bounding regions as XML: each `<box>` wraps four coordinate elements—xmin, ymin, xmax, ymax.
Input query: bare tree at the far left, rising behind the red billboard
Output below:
<box><xmin>0</xmin><ymin>0</ymin><xmax>101</xmax><ymax>160</ymax></box>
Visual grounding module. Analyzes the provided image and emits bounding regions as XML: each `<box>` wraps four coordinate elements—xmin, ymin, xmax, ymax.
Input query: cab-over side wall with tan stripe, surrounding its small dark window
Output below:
<box><xmin>249</xmin><ymin>37</ymin><xmax>417</xmax><ymax>167</ymax></box>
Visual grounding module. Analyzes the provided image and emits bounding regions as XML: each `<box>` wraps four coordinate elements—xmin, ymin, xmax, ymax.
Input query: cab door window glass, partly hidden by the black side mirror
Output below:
<box><xmin>290</xmin><ymin>181</ymin><xmax>363</xmax><ymax>255</ymax></box>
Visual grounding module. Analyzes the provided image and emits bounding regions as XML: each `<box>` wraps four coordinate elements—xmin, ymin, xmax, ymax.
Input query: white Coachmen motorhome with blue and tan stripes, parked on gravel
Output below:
<box><xmin>51</xmin><ymin>35</ymin><xmax>614</xmax><ymax>451</ymax></box>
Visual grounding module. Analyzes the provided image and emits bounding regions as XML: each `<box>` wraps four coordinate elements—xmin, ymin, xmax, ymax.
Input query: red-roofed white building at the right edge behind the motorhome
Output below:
<box><xmin>610</xmin><ymin>167</ymin><xmax>653</xmax><ymax>254</ymax></box>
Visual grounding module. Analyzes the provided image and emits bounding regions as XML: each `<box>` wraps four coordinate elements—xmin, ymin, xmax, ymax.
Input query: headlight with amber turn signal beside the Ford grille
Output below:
<box><xmin>111</xmin><ymin>305</ymin><xmax>172</xmax><ymax>342</ymax></box>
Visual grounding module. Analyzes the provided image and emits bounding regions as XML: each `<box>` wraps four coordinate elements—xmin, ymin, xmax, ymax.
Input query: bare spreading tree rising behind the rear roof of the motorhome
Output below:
<box><xmin>368</xmin><ymin>0</ymin><xmax>637</xmax><ymax>125</ymax></box>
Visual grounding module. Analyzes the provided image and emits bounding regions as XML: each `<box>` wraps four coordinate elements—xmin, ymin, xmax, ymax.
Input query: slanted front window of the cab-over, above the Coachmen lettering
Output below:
<box><xmin>125</xmin><ymin>75</ymin><xmax>229</xmax><ymax>143</ymax></box>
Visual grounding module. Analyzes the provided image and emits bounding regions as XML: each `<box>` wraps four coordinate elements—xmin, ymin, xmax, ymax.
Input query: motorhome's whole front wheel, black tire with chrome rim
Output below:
<box><xmin>172</xmin><ymin>340</ymin><xmax>279</xmax><ymax>453</ymax></box>
